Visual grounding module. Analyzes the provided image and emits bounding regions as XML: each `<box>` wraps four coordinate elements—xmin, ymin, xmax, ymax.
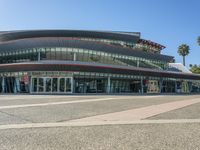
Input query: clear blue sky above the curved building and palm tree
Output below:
<box><xmin>0</xmin><ymin>0</ymin><xmax>200</xmax><ymax>65</ymax></box>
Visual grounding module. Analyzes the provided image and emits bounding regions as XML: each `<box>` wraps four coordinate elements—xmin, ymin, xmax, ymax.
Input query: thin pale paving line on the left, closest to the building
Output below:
<box><xmin>0</xmin><ymin>98</ymin><xmax>115</xmax><ymax>110</ymax></box>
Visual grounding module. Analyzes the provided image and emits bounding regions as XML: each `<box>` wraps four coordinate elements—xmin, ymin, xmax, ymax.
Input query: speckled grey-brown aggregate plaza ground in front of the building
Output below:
<box><xmin>0</xmin><ymin>95</ymin><xmax>200</xmax><ymax>150</ymax></box>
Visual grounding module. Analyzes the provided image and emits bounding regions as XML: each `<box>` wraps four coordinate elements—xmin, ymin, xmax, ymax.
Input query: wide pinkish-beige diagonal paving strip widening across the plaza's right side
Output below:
<box><xmin>70</xmin><ymin>98</ymin><xmax>200</xmax><ymax>122</ymax></box>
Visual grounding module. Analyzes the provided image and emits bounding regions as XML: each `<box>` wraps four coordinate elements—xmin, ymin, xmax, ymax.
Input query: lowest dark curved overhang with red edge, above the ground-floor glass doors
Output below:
<box><xmin>0</xmin><ymin>61</ymin><xmax>200</xmax><ymax>81</ymax></box>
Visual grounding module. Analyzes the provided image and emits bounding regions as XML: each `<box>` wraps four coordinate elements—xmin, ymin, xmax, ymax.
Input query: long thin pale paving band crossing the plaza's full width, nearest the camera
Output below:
<box><xmin>0</xmin><ymin>119</ymin><xmax>200</xmax><ymax>130</ymax></box>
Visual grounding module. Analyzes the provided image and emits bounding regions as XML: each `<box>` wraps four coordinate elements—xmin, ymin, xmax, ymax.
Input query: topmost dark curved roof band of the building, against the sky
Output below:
<box><xmin>0</xmin><ymin>30</ymin><xmax>140</xmax><ymax>42</ymax></box>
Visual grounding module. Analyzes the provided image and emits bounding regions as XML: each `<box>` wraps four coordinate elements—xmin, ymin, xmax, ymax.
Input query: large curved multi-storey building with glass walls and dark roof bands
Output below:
<box><xmin>0</xmin><ymin>30</ymin><xmax>200</xmax><ymax>94</ymax></box>
